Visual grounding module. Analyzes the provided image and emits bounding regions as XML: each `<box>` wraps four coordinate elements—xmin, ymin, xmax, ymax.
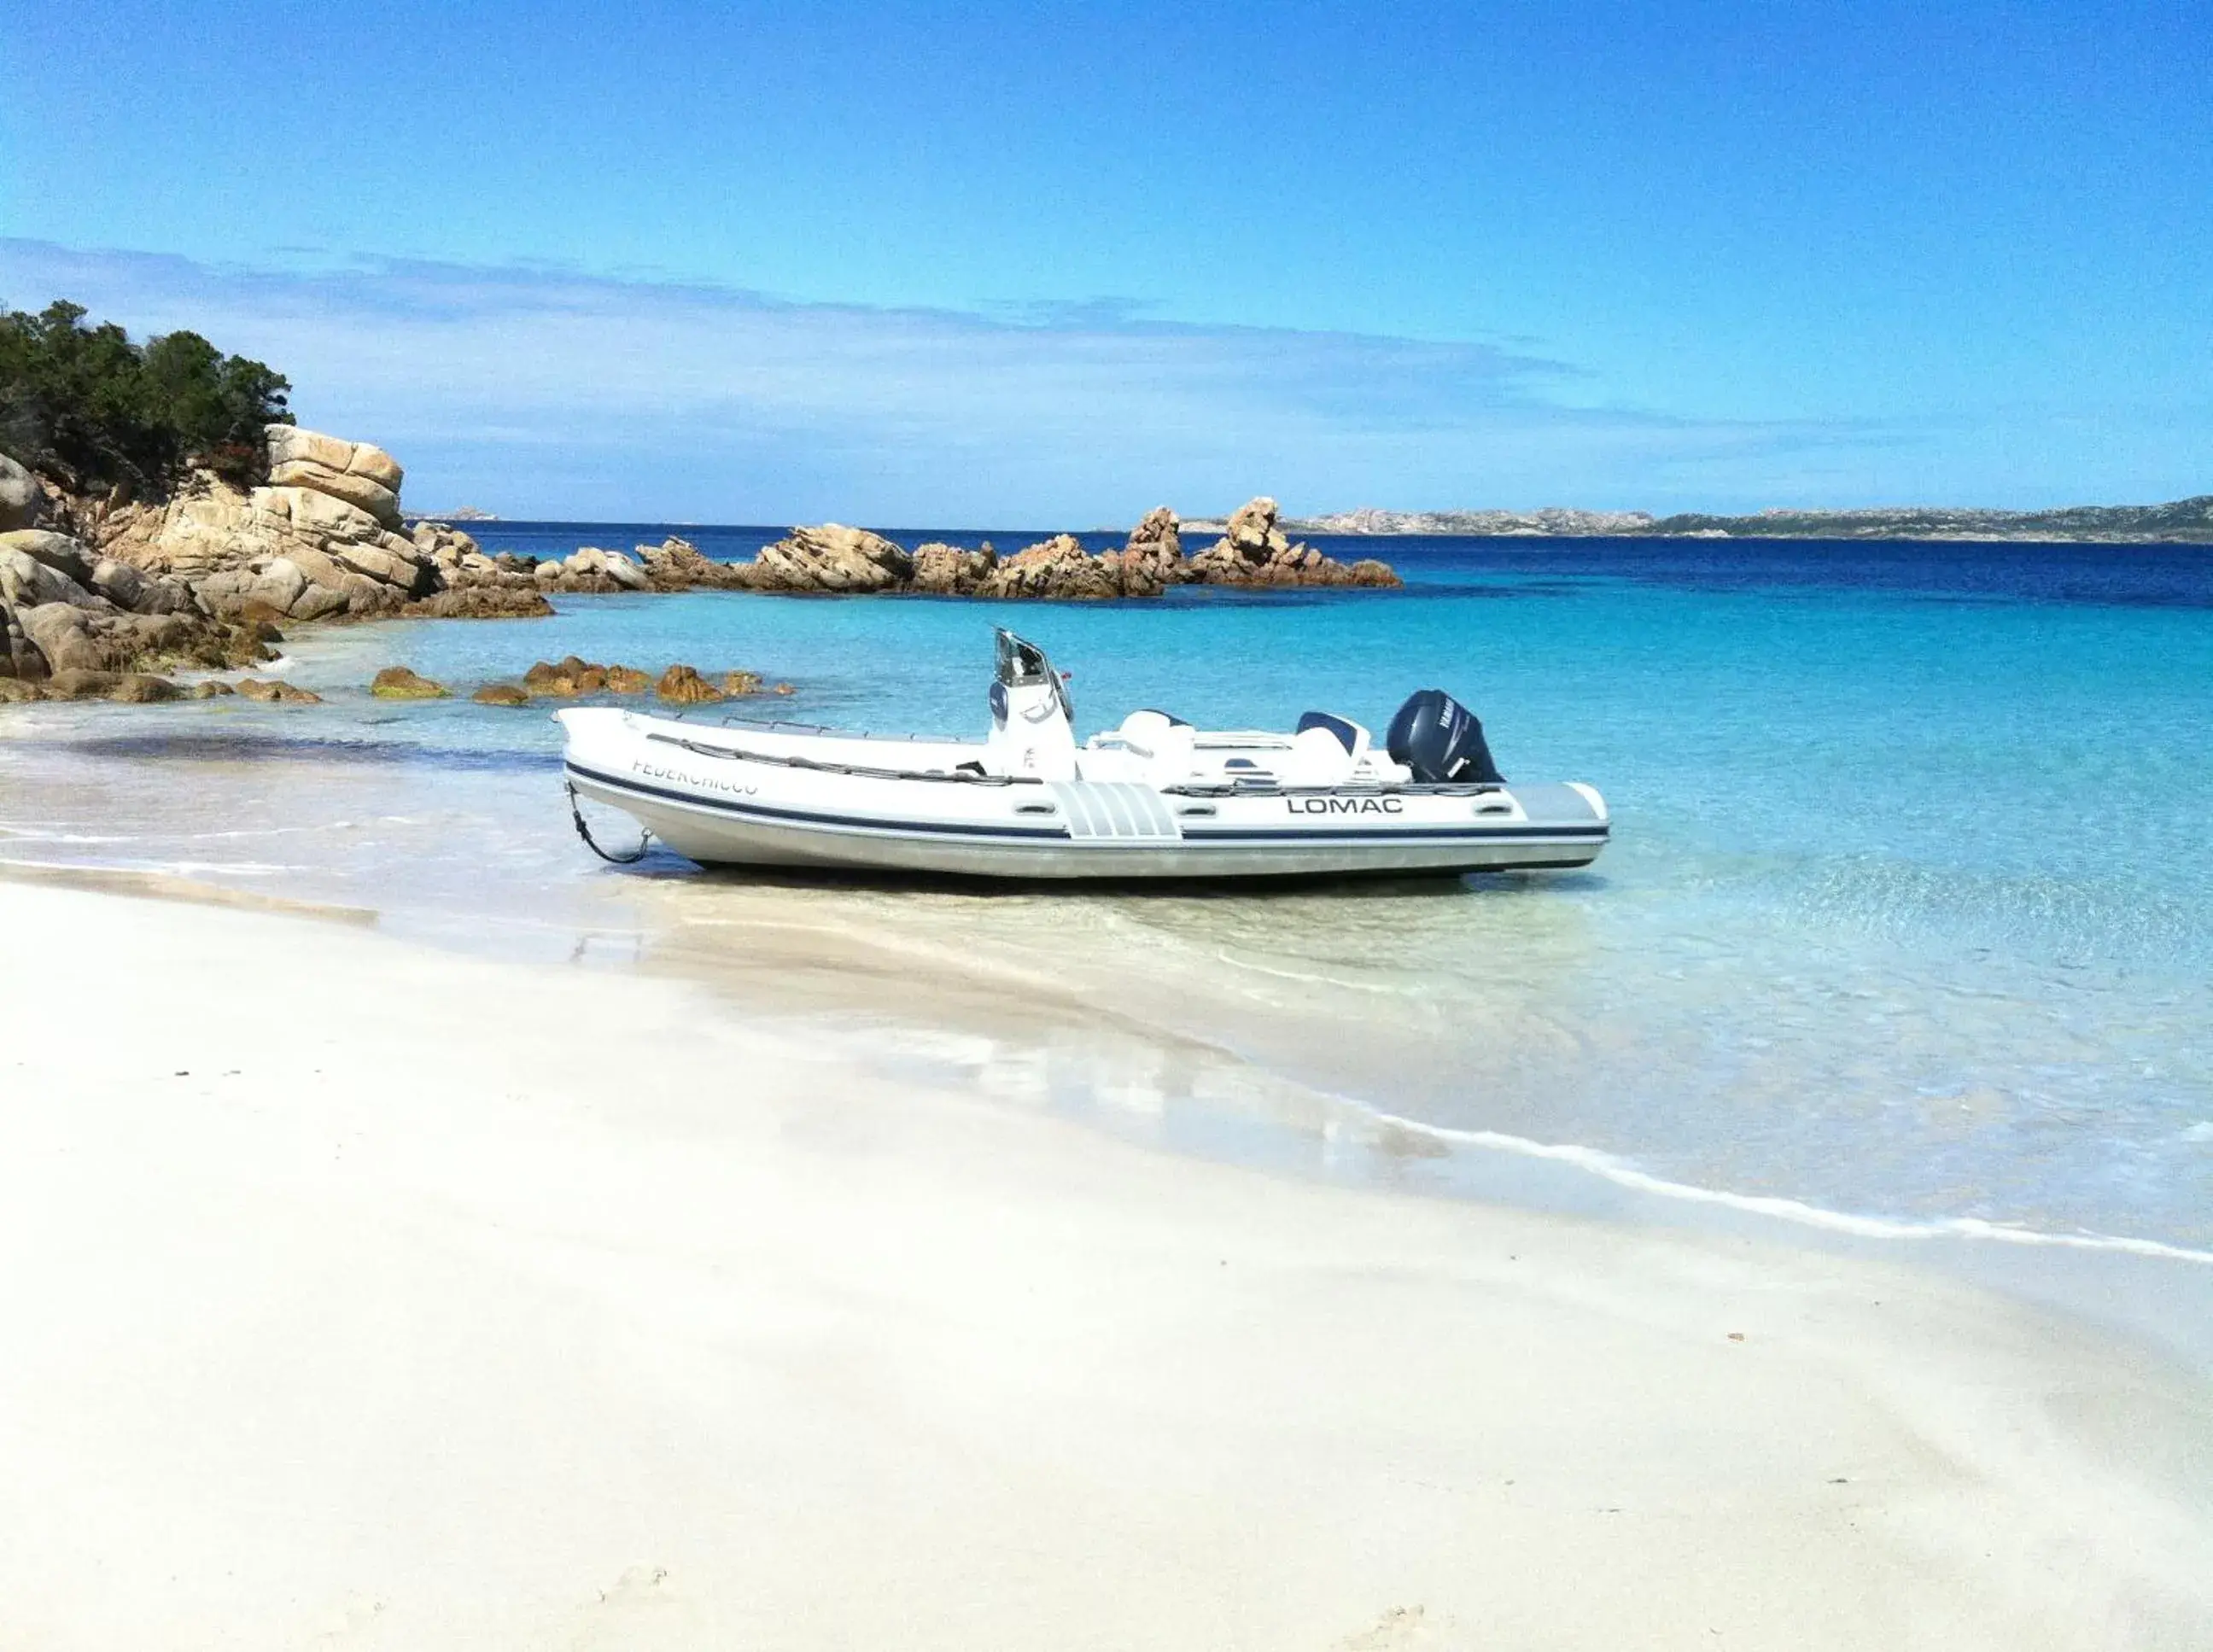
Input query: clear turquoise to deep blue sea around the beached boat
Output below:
<box><xmin>0</xmin><ymin>522</ymin><xmax>2213</xmax><ymax>1250</ymax></box>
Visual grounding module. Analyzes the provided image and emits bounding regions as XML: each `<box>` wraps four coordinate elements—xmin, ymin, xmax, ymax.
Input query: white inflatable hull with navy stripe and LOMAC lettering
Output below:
<box><xmin>560</xmin><ymin>710</ymin><xmax>1609</xmax><ymax>880</ymax></box>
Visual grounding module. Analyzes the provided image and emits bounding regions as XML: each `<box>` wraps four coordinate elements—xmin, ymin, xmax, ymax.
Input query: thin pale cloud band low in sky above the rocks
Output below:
<box><xmin>0</xmin><ymin>241</ymin><xmax>1907</xmax><ymax>524</ymax></box>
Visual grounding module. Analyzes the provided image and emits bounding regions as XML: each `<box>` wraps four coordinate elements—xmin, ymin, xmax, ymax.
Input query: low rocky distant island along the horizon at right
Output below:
<box><xmin>1265</xmin><ymin>493</ymin><xmax>2213</xmax><ymax>544</ymax></box>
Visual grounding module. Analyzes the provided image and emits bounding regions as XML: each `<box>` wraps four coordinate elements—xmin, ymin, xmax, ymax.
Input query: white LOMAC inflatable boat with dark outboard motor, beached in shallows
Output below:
<box><xmin>556</xmin><ymin>630</ymin><xmax>1609</xmax><ymax>880</ymax></box>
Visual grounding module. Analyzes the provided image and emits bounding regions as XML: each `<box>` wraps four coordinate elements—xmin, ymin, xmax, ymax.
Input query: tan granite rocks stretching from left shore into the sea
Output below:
<box><xmin>0</xmin><ymin>411</ymin><xmax>1397</xmax><ymax>699</ymax></box>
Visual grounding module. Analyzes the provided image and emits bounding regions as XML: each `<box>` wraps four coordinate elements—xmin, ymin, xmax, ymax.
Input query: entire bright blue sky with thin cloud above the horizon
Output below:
<box><xmin>0</xmin><ymin>0</ymin><xmax>2213</xmax><ymax>524</ymax></box>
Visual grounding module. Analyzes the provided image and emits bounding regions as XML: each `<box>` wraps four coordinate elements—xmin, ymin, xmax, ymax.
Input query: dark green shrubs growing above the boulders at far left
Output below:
<box><xmin>0</xmin><ymin>299</ymin><xmax>292</xmax><ymax>491</ymax></box>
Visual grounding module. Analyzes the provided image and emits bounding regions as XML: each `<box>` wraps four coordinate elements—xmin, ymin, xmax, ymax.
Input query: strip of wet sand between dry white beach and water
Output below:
<box><xmin>0</xmin><ymin>838</ymin><xmax>2213</xmax><ymax>1375</ymax></box>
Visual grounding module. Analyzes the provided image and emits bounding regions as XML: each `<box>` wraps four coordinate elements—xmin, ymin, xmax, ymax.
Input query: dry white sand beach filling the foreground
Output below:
<box><xmin>0</xmin><ymin>883</ymin><xmax>2213</xmax><ymax>1652</ymax></box>
